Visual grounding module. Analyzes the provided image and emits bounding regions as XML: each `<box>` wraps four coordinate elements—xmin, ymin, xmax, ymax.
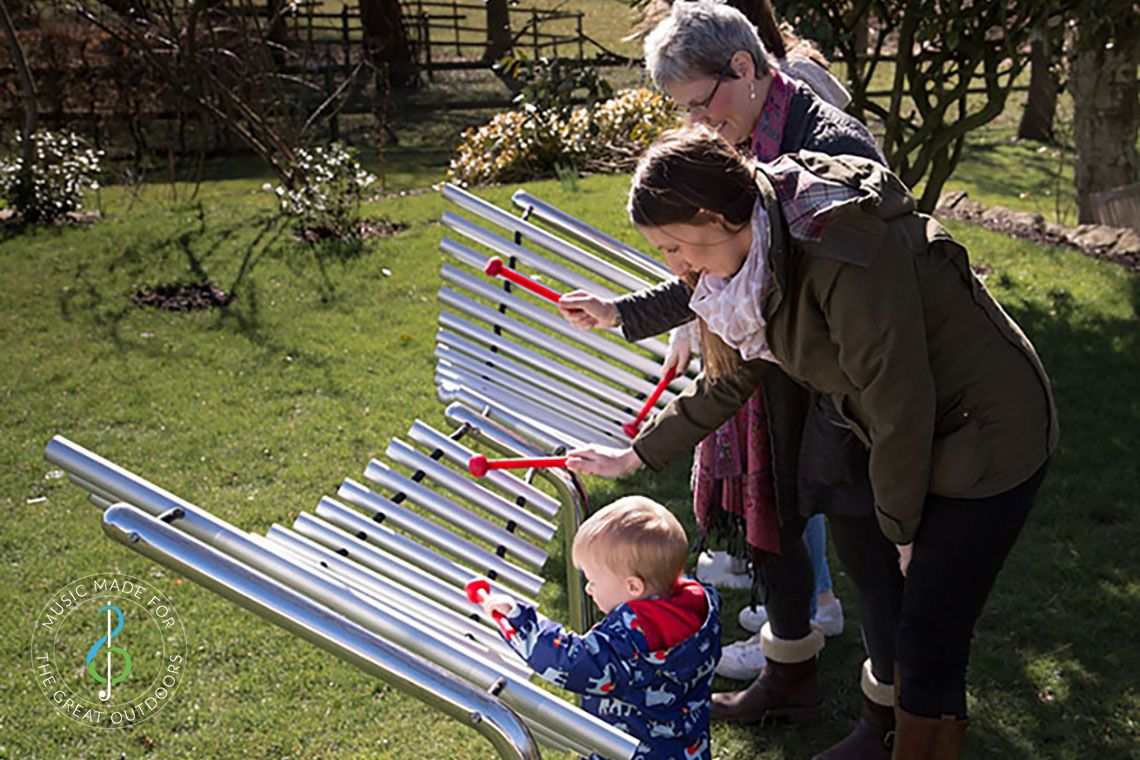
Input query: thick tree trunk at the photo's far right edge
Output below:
<box><xmin>1072</xmin><ymin>10</ymin><xmax>1140</xmax><ymax>223</ymax></box>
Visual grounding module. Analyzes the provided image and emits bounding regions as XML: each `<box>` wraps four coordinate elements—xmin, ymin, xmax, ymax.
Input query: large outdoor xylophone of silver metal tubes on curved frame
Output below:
<box><xmin>46</xmin><ymin>181</ymin><xmax>686</xmax><ymax>759</ymax></box>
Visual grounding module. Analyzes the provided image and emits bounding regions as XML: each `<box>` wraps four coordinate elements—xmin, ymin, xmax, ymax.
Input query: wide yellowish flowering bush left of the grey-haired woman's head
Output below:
<box><xmin>448</xmin><ymin>89</ymin><xmax>677</xmax><ymax>186</ymax></box>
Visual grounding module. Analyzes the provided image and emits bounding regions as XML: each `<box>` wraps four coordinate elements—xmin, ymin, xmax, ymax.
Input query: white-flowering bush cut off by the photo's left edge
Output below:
<box><xmin>0</xmin><ymin>130</ymin><xmax>103</xmax><ymax>224</ymax></box>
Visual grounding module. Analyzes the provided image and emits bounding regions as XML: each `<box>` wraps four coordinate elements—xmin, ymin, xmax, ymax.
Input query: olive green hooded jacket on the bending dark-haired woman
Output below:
<box><xmin>634</xmin><ymin>152</ymin><xmax>1058</xmax><ymax>544</ymax></box>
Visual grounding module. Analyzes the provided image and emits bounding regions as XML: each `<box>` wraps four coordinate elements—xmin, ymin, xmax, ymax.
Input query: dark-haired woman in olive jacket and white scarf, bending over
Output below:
<box><xmin>570</xmin><ymin>130</ymin><xmax>1058</xmax><ymax>760</ymax></box>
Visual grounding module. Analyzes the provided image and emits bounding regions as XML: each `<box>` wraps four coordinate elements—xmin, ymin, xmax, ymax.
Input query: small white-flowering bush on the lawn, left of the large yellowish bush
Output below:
<box><xmin>262</xmin><ymin>142</ymin><xmax>376</xmax><ymax>238</ymax></box>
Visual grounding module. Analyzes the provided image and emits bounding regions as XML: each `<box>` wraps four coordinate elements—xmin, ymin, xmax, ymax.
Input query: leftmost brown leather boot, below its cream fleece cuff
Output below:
<box><xmin>713</xmin><ymin>655</ymin><xmax>823</xmax><ymax>724</ymax></box>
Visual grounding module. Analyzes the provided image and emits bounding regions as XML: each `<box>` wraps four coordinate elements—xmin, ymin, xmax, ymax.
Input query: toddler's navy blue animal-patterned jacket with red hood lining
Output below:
<box><xmin>507</xmin><ymin>585</ymin><xmax>720</xmax><ymax>760</ymax></box>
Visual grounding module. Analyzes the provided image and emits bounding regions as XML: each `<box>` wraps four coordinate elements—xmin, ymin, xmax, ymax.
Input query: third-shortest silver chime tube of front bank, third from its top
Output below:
<box><xmin>364</xmin><ymin>459</ymin><xmax>547</xmax><ymax>570</ymax></box>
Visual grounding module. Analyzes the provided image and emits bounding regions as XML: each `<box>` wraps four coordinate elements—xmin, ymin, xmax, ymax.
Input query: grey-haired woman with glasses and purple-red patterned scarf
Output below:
<box><xmin>560</xmin><ymin>1</ymin><xmax>902</xmax><ymax>757</ymax></box>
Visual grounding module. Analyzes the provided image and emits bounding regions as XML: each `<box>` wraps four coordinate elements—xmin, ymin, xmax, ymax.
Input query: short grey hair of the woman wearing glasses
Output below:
<box><xmin>645</xmin><ymin>0</ymin><xmax>774</xmax><ymax>90</ymax></box>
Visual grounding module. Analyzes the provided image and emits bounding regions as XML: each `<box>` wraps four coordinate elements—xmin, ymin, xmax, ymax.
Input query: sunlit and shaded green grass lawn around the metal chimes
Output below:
<box><xmin>0</xmin><ymin>170</ymin><xmax>1140</xmax><ymax>760</ymax></box>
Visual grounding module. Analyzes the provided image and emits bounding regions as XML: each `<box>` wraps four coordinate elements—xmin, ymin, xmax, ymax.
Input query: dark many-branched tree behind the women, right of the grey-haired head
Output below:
<box><xmin>776</xmin><ymin>0</ymin><xmax>1064</xmax><ymax>211</ymax></box>
